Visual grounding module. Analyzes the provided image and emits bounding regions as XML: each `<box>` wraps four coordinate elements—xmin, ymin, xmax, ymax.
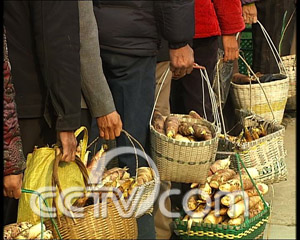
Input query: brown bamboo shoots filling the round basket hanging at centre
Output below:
<box><xmin>151</xmin><ymin>110</ymin><xmax>213</xmax><ymax>142</ymax></box>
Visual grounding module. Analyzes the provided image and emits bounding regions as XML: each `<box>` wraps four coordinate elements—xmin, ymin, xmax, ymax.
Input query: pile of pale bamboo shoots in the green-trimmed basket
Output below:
<box><xmin>182</xmin><ymin>158</ymin><xmax>268</xmax><ymax>227</ymax></box>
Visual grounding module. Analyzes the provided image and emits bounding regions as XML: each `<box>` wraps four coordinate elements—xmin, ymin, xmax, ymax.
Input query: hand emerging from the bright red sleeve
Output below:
<box><xmin>222</xmin><ymin>34</ymin><xmax>239</xmax><ymax>62</ymax></box>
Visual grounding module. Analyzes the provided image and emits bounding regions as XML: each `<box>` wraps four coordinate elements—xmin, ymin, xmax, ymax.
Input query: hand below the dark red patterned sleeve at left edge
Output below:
<box><xmin>3</xmin><ymin>173</ymin><xmax>23</xmax><ymax>199</ymax></box>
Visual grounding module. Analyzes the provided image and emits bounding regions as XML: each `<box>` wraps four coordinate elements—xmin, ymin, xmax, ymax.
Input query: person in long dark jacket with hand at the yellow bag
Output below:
<box><xmin>3</xmin><ymin>1</ymin><xmax>81</xmax><ymax>224</ymax></box>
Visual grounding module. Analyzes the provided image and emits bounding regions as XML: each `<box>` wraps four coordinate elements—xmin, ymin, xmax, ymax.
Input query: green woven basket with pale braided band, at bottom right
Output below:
<box><xmin>174</xmin><ymin>153</ymin><xmax>270</xmax><ymax>239</ymax></box>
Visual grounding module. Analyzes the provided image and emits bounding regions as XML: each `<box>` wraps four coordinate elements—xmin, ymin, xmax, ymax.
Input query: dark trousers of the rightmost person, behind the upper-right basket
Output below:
<box><xmin>252</xmin><ymin>0</ymin><xmax>296</xmax><ymax>74</ymax></box>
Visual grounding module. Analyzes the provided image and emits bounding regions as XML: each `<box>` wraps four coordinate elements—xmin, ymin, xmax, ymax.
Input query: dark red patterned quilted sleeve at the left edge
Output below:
<box><xmin>3</xmin><ymin>29</ymin><xmax>25</xmax><ymax>176</ymax></box>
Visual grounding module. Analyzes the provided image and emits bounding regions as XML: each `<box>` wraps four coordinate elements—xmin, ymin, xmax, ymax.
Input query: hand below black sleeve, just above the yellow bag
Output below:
<box><xmin>58</xmin><ymin>131</ymin><xmax>77</xmax><ymax>162</ymax></box>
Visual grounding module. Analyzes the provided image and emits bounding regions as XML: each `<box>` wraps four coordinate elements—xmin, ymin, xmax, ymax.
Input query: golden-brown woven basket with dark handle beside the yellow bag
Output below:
<box><xmin>45</xmin><ymin>136</ymin><xmax>137</xmax><ymax>239</ymax></box>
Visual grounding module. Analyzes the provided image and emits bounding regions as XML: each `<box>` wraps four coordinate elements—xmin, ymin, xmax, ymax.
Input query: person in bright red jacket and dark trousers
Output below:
<box><xmin>171</xmin><ymin>0</ymin><xmax>245</xmax><ymax>121</ymax></box>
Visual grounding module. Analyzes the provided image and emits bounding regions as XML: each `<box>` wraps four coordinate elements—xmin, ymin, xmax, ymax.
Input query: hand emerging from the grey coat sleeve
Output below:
<box><xmin>97</xmin><ymin>111</ymin><xmax>123</xmax><ymax>140</ymax></box>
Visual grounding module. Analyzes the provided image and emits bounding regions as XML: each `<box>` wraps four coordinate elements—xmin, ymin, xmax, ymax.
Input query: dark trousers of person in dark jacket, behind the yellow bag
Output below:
<box><xmin>3</xmin><ymin>110</ymin><xmax>91</xmax><ymax>225</ymax></box>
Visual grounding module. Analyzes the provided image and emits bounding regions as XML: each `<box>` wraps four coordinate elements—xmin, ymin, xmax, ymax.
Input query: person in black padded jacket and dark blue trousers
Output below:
<box><xmin>94</xmin><ymin>0</ymin><xmax>194</xmax><ymax>239</ymax></box>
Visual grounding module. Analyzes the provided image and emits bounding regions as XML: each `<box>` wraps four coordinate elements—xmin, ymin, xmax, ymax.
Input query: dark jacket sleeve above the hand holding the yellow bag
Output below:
<box><xmin>30</xmin><ymin>1</ymin><xmax>81</xmax><ymax>131</ymax></box>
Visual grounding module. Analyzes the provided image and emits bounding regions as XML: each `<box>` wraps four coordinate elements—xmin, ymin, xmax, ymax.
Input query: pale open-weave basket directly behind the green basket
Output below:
<box><xmin>218</xmin><ymin>115</ymin><xmax>288</xmax><ymax>184</ymax></box>
